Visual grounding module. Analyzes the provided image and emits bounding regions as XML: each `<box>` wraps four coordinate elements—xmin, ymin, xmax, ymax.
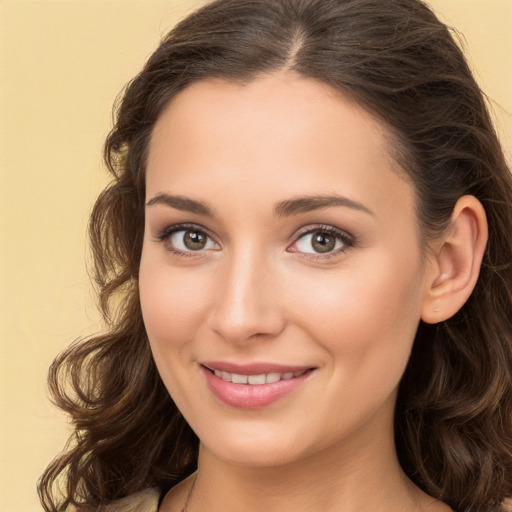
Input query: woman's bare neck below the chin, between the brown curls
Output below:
<box><xmin>189</xmin><ymin>412</ymin><xmax>434</xmax><ymax>512</ymax></box>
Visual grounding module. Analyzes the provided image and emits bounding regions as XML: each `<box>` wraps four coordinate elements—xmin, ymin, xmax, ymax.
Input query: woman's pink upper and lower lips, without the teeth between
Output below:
<box><xmin>199</xmin><ymin>362</ymin><xmax>315</xmax><ymax>409</ymax></box>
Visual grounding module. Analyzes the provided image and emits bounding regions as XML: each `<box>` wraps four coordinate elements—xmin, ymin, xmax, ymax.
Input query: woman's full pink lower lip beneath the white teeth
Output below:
<box><xmin>201</xmin><ymin>367</ymin><xmax>313</xmax><ymax>409</ymax></box>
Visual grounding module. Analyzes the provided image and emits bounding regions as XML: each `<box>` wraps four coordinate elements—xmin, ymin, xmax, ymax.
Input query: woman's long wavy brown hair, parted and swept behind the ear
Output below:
<box><xmin>39</xmin><ymin>0</ymin><xmax>512</xmax><ymax>512</ymax></box>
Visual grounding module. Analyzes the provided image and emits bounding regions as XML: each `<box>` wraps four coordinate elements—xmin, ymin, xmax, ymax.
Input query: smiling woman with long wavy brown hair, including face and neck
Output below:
<box><xmin>40</xmin><ymin>0</ymin><xmax>512</xmax><ymax>512</ymax></box>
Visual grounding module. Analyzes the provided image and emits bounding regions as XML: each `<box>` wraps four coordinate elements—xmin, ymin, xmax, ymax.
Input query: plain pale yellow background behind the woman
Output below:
<box><xmin>0</xmin><ymin>0</ymin><xmax>512</xmax><ymax>512</ymax></box>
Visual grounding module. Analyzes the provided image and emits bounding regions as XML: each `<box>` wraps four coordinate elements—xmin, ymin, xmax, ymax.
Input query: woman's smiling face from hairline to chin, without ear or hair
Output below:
<box><xmin>140</xmin><ymin>73</ymin><xmax>428</xmax><ymax>465</ymax></box>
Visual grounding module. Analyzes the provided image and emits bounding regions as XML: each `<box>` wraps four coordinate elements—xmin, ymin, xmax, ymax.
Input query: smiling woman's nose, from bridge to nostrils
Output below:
<box><xmin>209</xmin><ymin>247</ymin><xmax>285</xmax><ymax>344</ymax></box>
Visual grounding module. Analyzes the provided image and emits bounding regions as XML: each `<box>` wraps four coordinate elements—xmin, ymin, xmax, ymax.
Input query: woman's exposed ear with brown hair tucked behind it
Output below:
<box><xmin>421</xmin><ymin>196</ymin><xmax>488</xmax><ymax>324</ymax></box>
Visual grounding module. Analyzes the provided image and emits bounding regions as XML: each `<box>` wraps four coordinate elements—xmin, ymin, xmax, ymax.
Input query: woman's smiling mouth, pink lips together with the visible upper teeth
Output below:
<box><xmin>200</xmin><ymin>363</ymin><xmax>317</xmax><ymax>409</ymax></box>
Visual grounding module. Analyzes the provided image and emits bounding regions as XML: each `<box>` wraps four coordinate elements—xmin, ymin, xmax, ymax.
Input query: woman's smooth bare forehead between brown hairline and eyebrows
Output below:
<box><xmin>147</xmin><ymin>73</ymin><xmax>413</xmax><ymax>226</ymax></box>
